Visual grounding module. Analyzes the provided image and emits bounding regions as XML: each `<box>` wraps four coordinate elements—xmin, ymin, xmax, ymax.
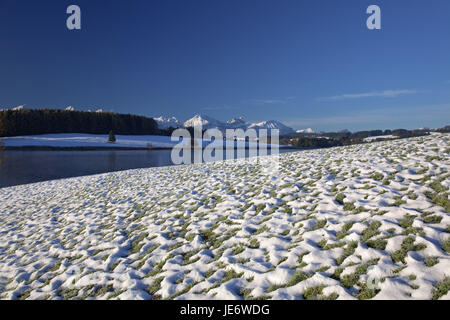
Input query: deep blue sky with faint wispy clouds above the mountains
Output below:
<box><xmin>0</xmin><ymin>0</ymin><xmax>450</xmax><ymax>130</ymax></box>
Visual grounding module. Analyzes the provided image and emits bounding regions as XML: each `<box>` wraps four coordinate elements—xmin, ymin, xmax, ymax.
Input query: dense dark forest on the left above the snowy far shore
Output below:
<box><xmin>0</xmin><ymin>109</ymin><xmax>170</xmax><ymax>137</ymax></box>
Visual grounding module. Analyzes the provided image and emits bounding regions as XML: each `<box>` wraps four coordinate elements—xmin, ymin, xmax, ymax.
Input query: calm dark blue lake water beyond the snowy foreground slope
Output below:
<box><xmin>0</xmin><ymin>149</ymin><xmax>298</xmax><ymax>188</ymax></box>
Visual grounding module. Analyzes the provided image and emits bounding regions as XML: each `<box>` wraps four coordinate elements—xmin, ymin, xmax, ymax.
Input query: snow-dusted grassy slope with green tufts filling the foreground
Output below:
<box><xmin>0</xmin><ymin>135</ymin><xmax>450</xmax><ymax>299</ymax></box>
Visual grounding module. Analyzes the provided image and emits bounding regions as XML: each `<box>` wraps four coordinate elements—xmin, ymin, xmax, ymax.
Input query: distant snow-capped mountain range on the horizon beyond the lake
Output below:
<box><xmin>154</xmin><ymin>115</ymin><xmax>295</xmax><ymax>135</ymax></box>
